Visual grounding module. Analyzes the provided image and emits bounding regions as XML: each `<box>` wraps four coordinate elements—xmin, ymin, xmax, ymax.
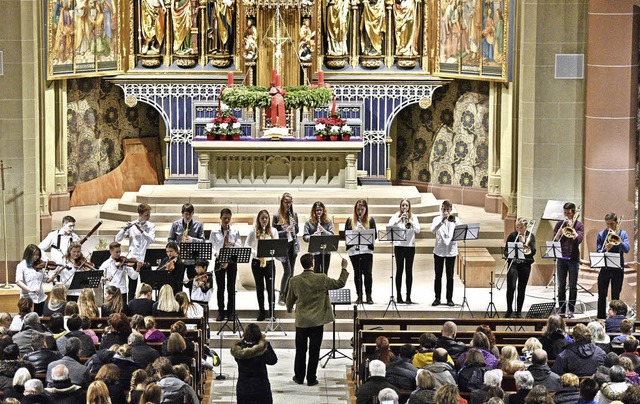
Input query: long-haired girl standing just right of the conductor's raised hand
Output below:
<box><xmin>344</xmin><ymin>199</ymin><xmax>377</xmax><ymax>304</ymax></box>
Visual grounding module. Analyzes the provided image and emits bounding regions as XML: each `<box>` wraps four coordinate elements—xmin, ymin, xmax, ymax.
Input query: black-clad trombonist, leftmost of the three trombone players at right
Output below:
<box><xmin>504</xmin><ymin>217</ymin><xmax>536</xmax><ymax>318</ymax></box>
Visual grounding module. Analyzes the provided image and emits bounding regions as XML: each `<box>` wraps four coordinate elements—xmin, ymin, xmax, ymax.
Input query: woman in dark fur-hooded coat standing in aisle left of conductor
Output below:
<box><xmin>231</xmin><ymin>323</ymin><xmax>278</xmax><ymax>404</ymax></box>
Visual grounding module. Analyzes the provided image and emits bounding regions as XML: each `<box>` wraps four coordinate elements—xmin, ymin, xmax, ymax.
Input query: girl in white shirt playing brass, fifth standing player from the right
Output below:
<box><xmin>389</xmin><ymin>199</ymin><xmax>420</xmax><ymax>304</ymax></box>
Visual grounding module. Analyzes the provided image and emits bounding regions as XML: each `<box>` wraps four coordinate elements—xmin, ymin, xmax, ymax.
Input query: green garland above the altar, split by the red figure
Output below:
<box><xmin>220</xmin><ymin>86</ymin><xmax>333</xmax><ymax>109</ymax></box>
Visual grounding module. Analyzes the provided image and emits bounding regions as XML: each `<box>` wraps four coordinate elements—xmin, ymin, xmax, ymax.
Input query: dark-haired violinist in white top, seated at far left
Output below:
<box><xmin>16</xmin><ymin>244</ymin><xmax>49</xmax><ymax>316</ymax></box>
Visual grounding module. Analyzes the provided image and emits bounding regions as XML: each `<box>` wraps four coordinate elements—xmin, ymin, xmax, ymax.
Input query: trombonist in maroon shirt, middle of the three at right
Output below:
<box><xmin>553</xmin><ymin>202</ymin><xmax>584</xmax><ymax>318</ymax></box>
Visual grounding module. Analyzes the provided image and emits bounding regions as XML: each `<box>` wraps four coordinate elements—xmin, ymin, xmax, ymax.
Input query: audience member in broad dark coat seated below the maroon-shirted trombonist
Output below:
<box><xmin>551</xmin><ymin>324</ymin><xmax>606</xmax><ymax>376</ymax></box>
